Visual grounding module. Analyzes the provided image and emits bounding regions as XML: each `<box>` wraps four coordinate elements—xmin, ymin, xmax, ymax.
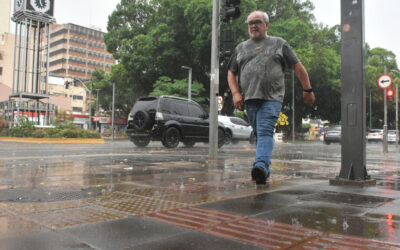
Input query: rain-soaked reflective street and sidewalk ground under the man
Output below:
<box><xmin>0</xmin><ymin>141</ymin><xmax>400</xmax><ymax>249</ymax></box>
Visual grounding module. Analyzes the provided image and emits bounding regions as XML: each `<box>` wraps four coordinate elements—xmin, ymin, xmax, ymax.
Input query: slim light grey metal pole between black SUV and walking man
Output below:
<box><xmin>208</xmin><ymin>0</ymin><xmax>219</xmax><ymax>160</ymax></box>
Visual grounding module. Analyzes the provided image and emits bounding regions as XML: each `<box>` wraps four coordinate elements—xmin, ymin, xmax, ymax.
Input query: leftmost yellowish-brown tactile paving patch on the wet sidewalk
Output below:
<box><xmin>25</xmin><ymin>206</ymin><xmax>127</xmax><ymax>229</ymax></box>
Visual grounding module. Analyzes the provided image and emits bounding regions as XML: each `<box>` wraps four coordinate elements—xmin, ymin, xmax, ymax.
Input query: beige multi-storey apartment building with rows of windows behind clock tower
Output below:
<box><xmin>50</xmin><ymin>23</ymin><xmax>115</xmax><ymax>80</ymax></box>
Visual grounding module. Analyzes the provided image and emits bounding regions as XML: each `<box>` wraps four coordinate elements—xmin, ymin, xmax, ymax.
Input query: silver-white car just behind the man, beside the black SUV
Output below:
<box><xmin>218</xmin><ymin>115</ymin><xmax>253</xmax><ymax>144</ymax></box>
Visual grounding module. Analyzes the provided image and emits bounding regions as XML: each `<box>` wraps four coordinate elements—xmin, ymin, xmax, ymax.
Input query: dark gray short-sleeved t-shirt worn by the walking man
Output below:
<box><xmin>228</xmin><ymin>36</ymin><xmax>300</xmax><ymax>102</ymax></box>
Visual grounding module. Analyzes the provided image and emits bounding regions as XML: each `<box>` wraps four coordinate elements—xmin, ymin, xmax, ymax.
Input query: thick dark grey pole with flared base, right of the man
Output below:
<box><xmin>329</xmin><ymin>0</ymin><xmax>376</xmax><ymax>187</ymax></box>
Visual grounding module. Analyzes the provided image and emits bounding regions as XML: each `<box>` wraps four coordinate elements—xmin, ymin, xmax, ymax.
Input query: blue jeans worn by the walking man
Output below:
<box><xmin>245</xmin><ymin>100</ymin><xmax>282</xmax><ymax>173</ymax></box>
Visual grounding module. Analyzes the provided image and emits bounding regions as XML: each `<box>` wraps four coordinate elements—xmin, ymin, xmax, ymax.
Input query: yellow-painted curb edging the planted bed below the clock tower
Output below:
<box><xmin>0</xmin><ymin>137</ymin><xmax>104</xmax><ymax>144</ymax></box>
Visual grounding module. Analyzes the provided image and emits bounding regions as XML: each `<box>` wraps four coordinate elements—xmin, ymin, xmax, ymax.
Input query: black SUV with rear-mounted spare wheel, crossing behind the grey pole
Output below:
<box><xmin>126</xmin><ymin>96</ymin><xmax>225</xmax><ymax>148</ymax></box>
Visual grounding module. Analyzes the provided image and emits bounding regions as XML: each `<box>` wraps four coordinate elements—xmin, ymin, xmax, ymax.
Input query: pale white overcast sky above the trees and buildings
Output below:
<box><xmin>11</xmin><ymin>0</ymin><xmax>400</xmax><ymax>66</ymax></box>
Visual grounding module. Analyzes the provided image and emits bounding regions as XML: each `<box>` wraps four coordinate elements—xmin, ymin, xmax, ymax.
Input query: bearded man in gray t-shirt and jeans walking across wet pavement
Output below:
<box><xmin>228</xmin><ymin>11</ymin><xmax>315</xmax><ymax>184</ymax></box>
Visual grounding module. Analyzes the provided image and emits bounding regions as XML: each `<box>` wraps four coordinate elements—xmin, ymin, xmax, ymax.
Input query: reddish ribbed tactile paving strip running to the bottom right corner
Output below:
<box><xmin>146</xmin><ymin>207</ymin><xmax>400</xmax><ymax>249</ymax></box>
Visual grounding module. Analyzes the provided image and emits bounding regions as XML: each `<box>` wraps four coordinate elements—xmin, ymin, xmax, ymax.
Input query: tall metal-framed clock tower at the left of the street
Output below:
<box><xmin>5</xmin><ymin>0</ymin><xmax>55</xmax><ymax>127</ymax></box>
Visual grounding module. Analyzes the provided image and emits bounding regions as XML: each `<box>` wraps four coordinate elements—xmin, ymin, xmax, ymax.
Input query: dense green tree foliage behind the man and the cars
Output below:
<box><xmin>101</xmin><ymin>0</ymin><xmax>397</xmax><ymax>134</ymax></box>
